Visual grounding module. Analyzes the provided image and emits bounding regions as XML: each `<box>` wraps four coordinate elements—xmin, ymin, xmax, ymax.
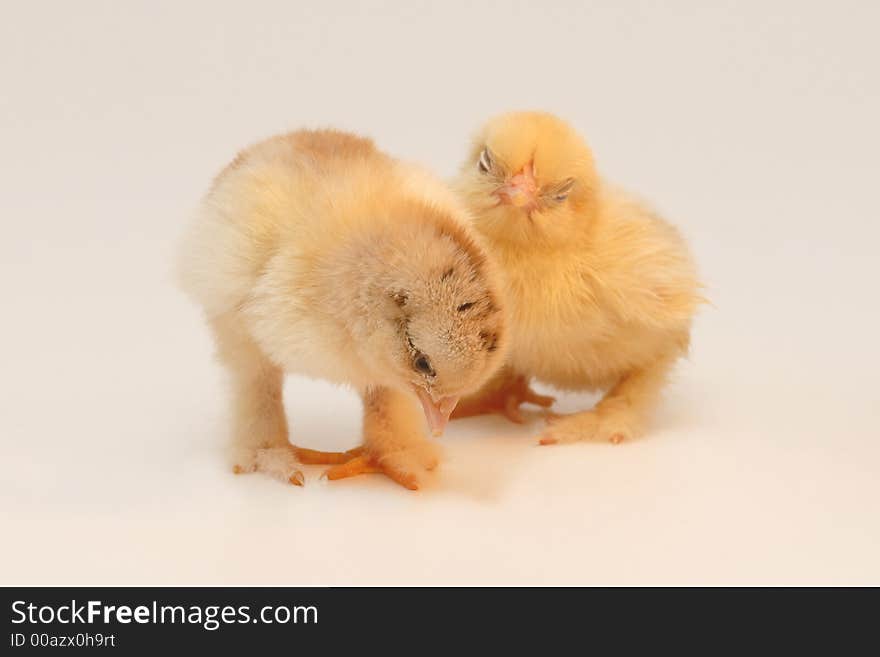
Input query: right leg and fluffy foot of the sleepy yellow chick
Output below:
<box><xmin>539</xmin><ymin>354</ymin><xmax>678</xmax><ymax>445</ymax></box>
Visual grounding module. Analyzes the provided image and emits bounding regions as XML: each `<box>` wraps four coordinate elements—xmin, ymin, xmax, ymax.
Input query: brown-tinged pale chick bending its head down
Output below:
<box><xmin>180</xmin><ymin>130</ymin><xmax>505</xmax><ymax>489</ymax></box>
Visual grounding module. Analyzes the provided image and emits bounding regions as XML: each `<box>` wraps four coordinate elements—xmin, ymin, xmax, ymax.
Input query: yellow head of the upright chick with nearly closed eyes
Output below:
<box><xmin>456</xmin><ymin>112</ymin><xmax>598</xmax><ymax>246</ymax></box>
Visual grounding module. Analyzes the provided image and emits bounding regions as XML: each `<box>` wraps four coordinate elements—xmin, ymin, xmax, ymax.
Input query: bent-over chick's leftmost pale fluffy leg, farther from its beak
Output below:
<box><xmin>212</xmin><ymin>316</ymin><xmax>303</xmax><ymax>486</ymax></box>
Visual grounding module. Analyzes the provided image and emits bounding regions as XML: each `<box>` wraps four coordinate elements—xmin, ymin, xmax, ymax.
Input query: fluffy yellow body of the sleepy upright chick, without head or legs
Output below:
<box><xmin>499</xmin><ymin>205</ymin><xmax>699</xmax><ymax>389</ymax></box>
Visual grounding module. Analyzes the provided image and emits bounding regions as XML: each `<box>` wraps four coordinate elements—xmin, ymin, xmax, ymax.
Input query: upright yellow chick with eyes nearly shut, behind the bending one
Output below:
<box><xmin>454</xmin><ymin>112</ymin><xmax>702</xmax><ymax>445</ymax></box>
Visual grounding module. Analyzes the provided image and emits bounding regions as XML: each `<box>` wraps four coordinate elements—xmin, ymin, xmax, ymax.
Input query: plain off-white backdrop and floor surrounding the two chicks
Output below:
<box><xmin>0</xmin><ymin>1</ymin><xmax>880</xmax><ymax>584</ymax></box>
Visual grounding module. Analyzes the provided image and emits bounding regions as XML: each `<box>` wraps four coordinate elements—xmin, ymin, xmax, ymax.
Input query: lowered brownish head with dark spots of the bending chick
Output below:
<box><xmin>360</xmin><ymin>208</ymin><xmax>505</xmax><ymax>435</ymax></box>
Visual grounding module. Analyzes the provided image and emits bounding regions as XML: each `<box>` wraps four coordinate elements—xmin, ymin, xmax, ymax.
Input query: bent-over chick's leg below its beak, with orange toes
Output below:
<box><xmin>320</xmin><ymin>388</ymin><xmax>440</xmax><ymax>490</ymax></box>
